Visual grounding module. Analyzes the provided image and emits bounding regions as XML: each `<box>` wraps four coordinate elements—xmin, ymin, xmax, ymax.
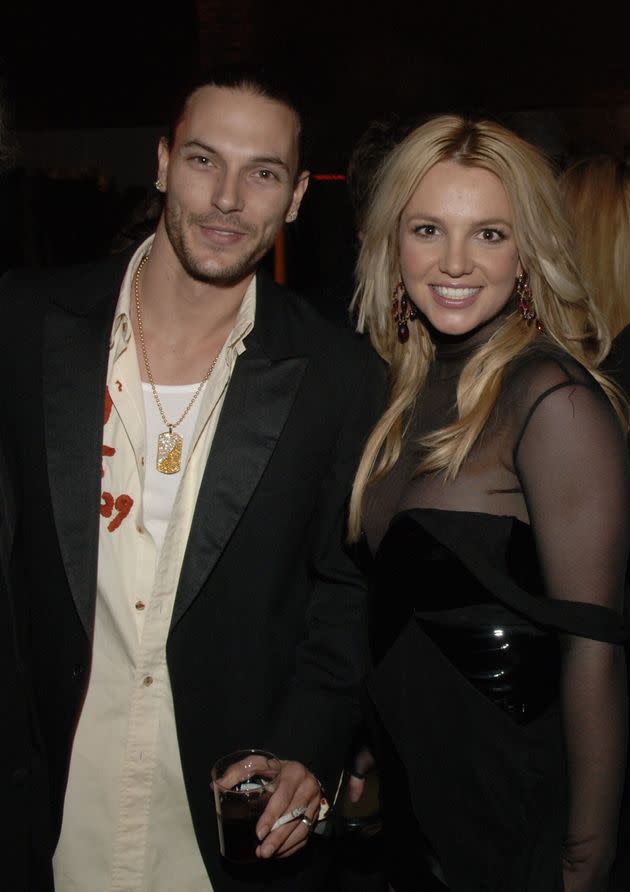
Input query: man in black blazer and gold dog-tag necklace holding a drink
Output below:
<box><xmin>0</xmin><ymin>68</ymin><xmax>382</xmax><ymax>892</ymax></box>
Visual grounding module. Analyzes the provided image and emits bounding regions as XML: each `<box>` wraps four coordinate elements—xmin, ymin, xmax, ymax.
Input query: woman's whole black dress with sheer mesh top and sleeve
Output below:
<box><xmin>364</xmin><ymin>324</ymin><xmax>630</xmax><ymax>892</ymax></box>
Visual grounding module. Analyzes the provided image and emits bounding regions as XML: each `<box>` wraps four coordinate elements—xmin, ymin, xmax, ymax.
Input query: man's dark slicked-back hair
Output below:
<box><xmin>167</xmin><ymin>62</ymin><xmax>308</xmax><ymax>172</ymax></box>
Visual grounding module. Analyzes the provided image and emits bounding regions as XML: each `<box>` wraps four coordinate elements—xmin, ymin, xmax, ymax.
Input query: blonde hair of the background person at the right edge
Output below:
<box><xmin>560</xmin><ymin>156</ymin><xmax>630</xmax><ymax>337</ymax></box>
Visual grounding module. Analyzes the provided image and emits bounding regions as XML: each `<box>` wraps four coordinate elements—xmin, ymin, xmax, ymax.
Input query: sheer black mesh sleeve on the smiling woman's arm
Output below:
<box><xmin>514</xmin><ymin>362</ymin><xmax>630</xmax><ymax>892</ymax></box>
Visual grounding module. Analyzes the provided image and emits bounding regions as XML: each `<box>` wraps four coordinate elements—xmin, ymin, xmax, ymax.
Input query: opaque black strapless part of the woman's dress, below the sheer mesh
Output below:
<box><xmin>366</xmin><ymin>509</ymin><xmax>564</xmax><ymax>892</ymax></box>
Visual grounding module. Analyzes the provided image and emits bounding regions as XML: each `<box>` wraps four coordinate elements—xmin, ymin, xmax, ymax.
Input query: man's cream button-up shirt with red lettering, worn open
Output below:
<box><xmin>54</xmin><ymin>238</ymin><xmax>256</xmax><ymax>892</ymax></box>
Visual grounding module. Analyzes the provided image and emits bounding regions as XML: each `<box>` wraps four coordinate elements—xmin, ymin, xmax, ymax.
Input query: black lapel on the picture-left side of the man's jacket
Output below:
<box><xmin>43</xmin><ymin>259</ymin><xmax>132</xmax><ymax>634</ymax></box>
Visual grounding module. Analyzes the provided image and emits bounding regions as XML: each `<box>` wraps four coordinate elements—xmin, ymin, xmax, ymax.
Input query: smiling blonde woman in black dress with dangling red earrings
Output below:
<box><xmin>351</xmin><ymin>116</ymin><xmax>630</xmax><ymax>892</ymax></box>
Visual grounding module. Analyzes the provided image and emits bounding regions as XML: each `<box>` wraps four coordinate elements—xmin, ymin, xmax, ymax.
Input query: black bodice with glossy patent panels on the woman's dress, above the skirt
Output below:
<box><xmin>372</xmin><ymin>509</ymin><xmax>560</xmax><ymax>724</ymax></box>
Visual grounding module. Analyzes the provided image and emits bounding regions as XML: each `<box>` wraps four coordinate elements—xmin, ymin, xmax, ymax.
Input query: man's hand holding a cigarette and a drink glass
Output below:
<box><xmin>256</xmin><ymin>760</ymin><xmax>322</xmax><ymax>859</ymax></box>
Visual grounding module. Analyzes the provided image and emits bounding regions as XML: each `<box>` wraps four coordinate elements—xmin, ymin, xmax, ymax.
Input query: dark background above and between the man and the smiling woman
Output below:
<box><xmin>0</xmin><ymin>0</ymin><xmax>630</xmax><ymax>318</ymax></box>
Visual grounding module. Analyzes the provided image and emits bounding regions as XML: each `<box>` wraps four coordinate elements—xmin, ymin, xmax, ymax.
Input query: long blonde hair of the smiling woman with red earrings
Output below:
<box><xmin>350</xmin><ymin>115</ymin><xmax>623</xmax><ymax>539</ymax></box>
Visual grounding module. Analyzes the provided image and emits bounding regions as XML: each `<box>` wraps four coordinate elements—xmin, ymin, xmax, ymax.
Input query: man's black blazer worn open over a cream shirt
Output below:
<box><xmin>0</xmin><ymin>252</ymin><xmax>384</xmax><ymax>892</ymax></box>
